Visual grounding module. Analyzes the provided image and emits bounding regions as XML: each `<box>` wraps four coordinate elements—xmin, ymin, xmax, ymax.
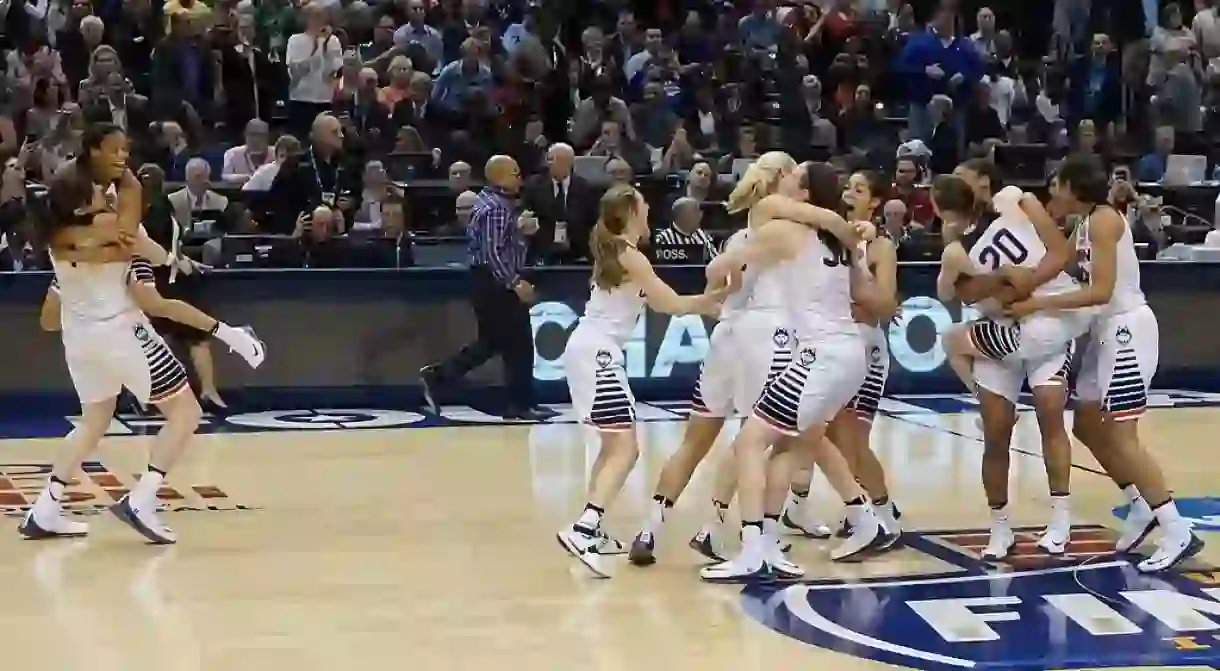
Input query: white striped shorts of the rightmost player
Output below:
<box><xmin>1076</xmin><ymin>305</ymin><xmax>1160</xmax><ymax>421</ymax></box>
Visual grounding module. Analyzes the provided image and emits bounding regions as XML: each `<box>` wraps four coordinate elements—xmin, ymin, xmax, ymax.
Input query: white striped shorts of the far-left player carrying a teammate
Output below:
<box><xmin>63</xmin><ymin>318</ymin><xmax>189</xmax><ymax>405</ymax></box>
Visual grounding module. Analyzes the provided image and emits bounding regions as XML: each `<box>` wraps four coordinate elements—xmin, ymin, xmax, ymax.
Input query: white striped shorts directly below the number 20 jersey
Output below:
<box><xmin>970</xmin><ymin>310</ymin><xmax>1096</xmax><ymax>361</ymax></box>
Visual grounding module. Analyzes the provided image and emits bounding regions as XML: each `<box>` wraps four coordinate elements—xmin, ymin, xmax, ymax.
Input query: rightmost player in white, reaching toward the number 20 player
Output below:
<box><xmin>1011</xmin><ymin>155</ymin><xmax>1203</xmax><ymax>573</ymax></box>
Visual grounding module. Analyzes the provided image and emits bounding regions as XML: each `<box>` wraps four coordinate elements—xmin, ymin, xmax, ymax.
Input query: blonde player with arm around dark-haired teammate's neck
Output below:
<box><xmin>631</xmin><ymin>151</ymin><xmax>868</xmax><ymax>566</ymax></box>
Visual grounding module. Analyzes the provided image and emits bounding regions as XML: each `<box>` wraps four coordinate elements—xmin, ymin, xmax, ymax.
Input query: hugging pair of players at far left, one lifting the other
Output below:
<box><xmin>20</xmin><ymin>127</ymin><xmax>264</xmax><ymax>544</ymax></box>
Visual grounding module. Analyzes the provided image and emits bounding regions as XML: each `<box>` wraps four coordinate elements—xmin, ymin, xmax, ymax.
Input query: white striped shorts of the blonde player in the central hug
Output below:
<box><xmin>691</xmin><ymin>310</ymin><xmax>794</xmax><ymax>418</ymax></box>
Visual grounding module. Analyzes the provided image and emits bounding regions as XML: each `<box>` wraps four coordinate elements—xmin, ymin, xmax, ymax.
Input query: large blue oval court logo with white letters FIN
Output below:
<box><xmin>743</xmin><ymin>527</ymin><xmax>1220</xmax><ymax>671</ymax></box>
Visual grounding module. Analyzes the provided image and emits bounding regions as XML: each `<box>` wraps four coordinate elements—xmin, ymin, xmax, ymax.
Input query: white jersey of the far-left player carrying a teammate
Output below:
<box><xmin>51</xmin><ymin>255</ymin><xmax>143</xmax><ymax>333</ymax></box>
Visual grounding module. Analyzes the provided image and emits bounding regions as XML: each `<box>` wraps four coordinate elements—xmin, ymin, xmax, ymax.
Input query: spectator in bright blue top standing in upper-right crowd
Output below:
<box><xmin>897</xmin><ymin>11</ymin><xmax>983</xmax><ymax>140</ymax></box>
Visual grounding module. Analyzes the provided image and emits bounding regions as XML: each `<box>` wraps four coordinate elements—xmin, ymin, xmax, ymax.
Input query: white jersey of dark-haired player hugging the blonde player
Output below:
<box><xmin>778</xmin><ymin>231</ymin><xmax>860</xmax><ymax>342</ymax></box>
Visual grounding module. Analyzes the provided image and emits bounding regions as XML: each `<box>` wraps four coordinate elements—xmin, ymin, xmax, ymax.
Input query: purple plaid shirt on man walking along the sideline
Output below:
<box><xmin>466</xmin><ymin>187</ymin><xmax>528</xmax><ymax>288</ymax></box>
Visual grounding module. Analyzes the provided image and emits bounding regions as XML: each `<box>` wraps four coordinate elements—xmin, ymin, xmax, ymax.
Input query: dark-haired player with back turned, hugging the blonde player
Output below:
<box><xmin>700</xmin><ymin>163</ymin><xmax>880</xmax><ymax>582</ymax></box>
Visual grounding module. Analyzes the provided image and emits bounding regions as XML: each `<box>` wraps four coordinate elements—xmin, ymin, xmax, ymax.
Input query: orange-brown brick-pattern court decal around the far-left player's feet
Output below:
<box><xmin>0</xmin><ymin>461</ymin><xmax>251</xmax><ymax>517</ymax></box>
